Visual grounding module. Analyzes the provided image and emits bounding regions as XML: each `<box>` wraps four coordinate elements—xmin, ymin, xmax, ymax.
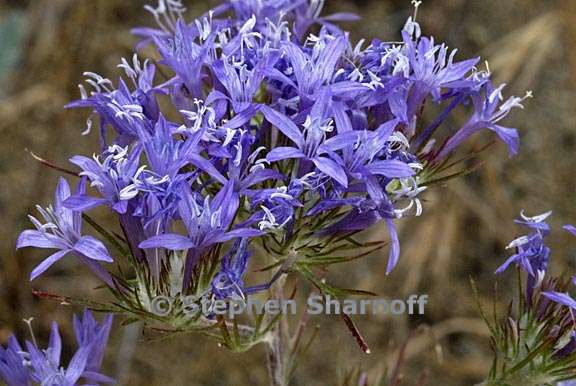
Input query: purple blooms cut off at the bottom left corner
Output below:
<box><xmin>0</xmin><ymin>311</ymin><xmax>115</xmax><ymax>386</ymax></box>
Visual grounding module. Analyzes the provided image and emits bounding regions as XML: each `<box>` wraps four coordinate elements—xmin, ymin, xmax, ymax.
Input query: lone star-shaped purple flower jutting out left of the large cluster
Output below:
<box><xmin>16</xmin><ymin>178</ymin><xmax>113</xmax><ymax>285</ymax></box>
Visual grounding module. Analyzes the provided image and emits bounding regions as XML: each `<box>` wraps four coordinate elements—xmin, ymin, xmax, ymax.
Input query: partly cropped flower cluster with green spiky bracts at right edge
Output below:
<box><xmin>484</xmin><ymin>212</ymin><xmax>576</xmax><ymax>386</ymax></box>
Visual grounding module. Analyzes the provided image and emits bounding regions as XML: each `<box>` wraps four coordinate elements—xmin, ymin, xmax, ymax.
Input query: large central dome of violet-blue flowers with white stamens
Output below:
<box><xmin>18</xmin><ymin>0</ymin><xmax>522</xmax><ymax>297</ymax></box>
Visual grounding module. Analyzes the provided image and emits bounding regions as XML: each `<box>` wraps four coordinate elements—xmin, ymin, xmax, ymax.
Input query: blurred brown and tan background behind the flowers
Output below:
<box><xmin>0</xmin><ymin>0</ymin><xmax>576</xmax><ymax>386</ymax></box>
